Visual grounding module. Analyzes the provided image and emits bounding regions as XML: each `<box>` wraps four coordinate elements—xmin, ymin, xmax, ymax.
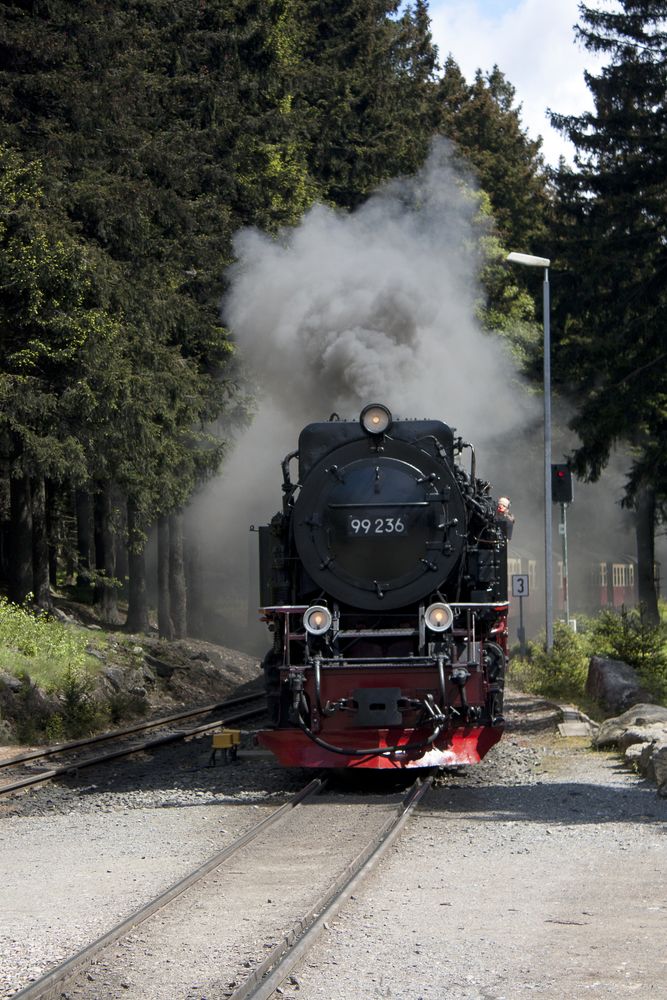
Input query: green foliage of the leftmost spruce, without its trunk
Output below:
<box><xmin>0</xmin><ymin>144</ymin><xmax>115</xmax><ymax>480</ymax></box>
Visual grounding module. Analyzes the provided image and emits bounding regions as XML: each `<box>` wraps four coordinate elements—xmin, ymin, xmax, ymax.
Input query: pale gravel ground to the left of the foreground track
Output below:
<box><xmin>0</xmin><ymin>738</ymin><xmax>307</xmax><ymax>998</ymax></box>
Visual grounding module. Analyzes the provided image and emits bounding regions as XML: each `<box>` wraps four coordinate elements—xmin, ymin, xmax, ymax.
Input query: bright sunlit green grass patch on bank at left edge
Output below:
<box><xmin>0</xmin><ymin>597</ymin><xmax>97</xmax><ymax>687</ymax></box>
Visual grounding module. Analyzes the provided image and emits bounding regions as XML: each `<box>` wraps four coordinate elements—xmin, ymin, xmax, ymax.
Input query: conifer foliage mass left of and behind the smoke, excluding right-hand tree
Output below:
<box><xmin>0</xmin><ymin>0</ymin><xmax>560</xmax><ymax>624</ymax></box>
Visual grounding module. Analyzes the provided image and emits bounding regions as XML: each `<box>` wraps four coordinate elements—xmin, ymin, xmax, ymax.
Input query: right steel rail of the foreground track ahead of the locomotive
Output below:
<box><xmin>228</xmin><ymin>777</ymin><xmax>433</xmax><ymax>1000</ymax></box>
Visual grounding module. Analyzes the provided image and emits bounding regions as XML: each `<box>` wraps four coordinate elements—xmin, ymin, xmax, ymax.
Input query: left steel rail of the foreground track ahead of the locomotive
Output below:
<box><xmin>12</xmin><ymin>778</ymin><xmax>326</xmax><ymax>1000</ymax></box>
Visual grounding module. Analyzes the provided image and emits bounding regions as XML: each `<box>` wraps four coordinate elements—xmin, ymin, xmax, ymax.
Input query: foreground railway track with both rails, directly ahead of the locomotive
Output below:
<box><xmin>13</xmin><ymin>778</ymin><xmax>430</xmax><ymax>1000</ymax></box>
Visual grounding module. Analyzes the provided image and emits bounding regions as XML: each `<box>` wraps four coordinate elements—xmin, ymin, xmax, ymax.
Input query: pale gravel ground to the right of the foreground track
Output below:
<box><xmin>282</xmin><ymin>700</ymin><xmax>667</xmax><ymax>1000</ymax></box>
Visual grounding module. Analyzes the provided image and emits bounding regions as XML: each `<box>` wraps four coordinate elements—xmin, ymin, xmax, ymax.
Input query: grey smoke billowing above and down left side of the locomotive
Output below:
<box><xmin>189</xmin><ymin>140</ymin><xmax>540</xmax><ymax>649</ymax></box>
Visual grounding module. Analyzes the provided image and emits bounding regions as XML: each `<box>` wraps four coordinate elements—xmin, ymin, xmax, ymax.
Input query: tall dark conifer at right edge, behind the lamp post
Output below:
<box><xmin>553</xmin><ymin>0</ymin><xmax>667</xmax><ymax>620</ymax></box>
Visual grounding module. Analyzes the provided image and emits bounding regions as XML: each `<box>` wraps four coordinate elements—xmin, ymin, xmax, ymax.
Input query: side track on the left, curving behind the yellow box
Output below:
<box><xmin>0</xmin><ymin>694</ymin><xmax>266</xmax><ymax>795</ymax></box>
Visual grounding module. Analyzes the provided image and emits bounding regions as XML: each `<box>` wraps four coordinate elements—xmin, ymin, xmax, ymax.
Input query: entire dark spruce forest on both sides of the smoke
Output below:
<box><xmin>0</xmin><ymin>0</ymin><xmax>667</xmax><ymax>637</ymax></box>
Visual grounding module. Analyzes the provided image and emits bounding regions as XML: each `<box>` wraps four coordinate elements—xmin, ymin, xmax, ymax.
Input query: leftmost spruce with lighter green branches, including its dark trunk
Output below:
<box><xmin>0</xmin><ymin>146</ymin><xmax>115</xmax><ymax>606</ymax></box>
